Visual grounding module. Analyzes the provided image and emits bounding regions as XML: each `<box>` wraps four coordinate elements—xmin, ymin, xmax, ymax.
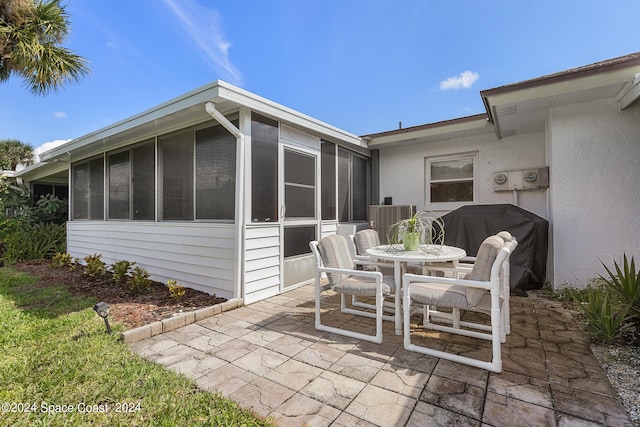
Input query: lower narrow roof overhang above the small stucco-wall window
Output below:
<box><xmin>362</xmin><ymin>114</ymin><xmax>493</xmax><ymax>149</ymax></box>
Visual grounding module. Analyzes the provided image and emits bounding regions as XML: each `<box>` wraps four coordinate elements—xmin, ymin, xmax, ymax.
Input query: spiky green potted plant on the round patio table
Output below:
<box><xmin>387</xmin><ymin>211</ymin><xmax>444</xmax><ymax>251</ymax></box>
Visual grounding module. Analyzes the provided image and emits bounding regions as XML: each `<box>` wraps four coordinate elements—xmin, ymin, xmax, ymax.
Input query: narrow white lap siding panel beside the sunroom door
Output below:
<box><xmin>244</xmin><ymin>225</ymin><xmax>280</xmax><ymax>304</ymax></box>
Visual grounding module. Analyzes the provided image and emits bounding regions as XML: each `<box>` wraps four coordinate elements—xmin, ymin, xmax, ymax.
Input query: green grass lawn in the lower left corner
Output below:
<box><xmin>0</xmin><ymin>267</ymin><xmax>272</xmax><ymax>426</ymax></box>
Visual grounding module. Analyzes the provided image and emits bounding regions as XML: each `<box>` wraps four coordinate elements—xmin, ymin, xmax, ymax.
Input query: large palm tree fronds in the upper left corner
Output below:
<box><xmin>0</xmin><ymin>0</ymin><xmax>89</xmax><ymax>95</ymax></box>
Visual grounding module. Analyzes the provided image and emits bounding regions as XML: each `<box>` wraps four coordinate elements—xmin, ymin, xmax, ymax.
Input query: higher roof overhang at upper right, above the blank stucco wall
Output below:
<box><xmin>480</xmin><ymin>52</ymin><xmax>640</xmax><ymax>138</ymax></box>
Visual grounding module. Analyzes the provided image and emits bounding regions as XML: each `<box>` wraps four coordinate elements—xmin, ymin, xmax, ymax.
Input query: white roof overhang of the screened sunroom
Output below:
<box><xmin>40</xmin><ymin>80</ymin><xmax>366</xmax><ymax>166</ymax></box>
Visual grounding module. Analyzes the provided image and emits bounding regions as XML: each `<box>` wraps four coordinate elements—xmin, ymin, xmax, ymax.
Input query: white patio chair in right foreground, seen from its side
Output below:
<box><xmin>403</xmin><ymin>236</ymin><xmax>512</xmax><ymax>372</ymax></box>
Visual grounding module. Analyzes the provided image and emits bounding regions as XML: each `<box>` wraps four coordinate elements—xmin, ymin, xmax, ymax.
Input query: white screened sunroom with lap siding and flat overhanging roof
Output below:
<box><xmin>35</xmin><ymin>81</ymin><xmax>371</xmax><ymax>303</ymax></box>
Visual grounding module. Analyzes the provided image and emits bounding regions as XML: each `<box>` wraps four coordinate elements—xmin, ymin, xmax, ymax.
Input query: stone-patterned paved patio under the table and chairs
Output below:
<box><xmin>130</xmin><ymin>285</ymin><xmax>633</xmax><ymax>427</ymax></box>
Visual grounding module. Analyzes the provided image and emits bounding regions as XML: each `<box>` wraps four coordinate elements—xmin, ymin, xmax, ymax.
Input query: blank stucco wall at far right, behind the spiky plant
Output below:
<box><xmin>549</xmin><ymin>99</ymin><xmax>640</xmax><ymax>288</ymax></box>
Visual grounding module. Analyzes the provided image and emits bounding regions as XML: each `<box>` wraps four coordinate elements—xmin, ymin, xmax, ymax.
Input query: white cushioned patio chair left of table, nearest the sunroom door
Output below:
<box><xmin>309</xmin><ymin>234</ymin><xmax>402</xmax><ymax>343</ymax></box>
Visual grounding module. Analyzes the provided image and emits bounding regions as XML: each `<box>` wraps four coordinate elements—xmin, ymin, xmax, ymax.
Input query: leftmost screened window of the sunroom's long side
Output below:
<box><xmin>71</xmin><ymin>156</ymin><xmax>104</xmax><ymax>220</ymax></box>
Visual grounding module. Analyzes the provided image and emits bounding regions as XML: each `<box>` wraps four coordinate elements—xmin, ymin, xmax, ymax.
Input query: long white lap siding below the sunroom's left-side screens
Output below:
<box><xmin>67</xmin><ymin>221</ymin><xmax>235</xmax><ymax>298</ymax></box>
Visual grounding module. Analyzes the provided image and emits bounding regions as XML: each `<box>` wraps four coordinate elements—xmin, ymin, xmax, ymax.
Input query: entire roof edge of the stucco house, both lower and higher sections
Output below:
<box><xmin>362</xmin><ymin>52</ymin><xmax>640</xmax><ymax>148</ymax></box>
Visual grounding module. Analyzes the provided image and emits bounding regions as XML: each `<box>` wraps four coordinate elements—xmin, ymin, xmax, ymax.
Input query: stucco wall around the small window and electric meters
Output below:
<box><xmin>380</xmin><ymin>132</ymin><xmax>548</xmax><ymax>218</ymax></box>
